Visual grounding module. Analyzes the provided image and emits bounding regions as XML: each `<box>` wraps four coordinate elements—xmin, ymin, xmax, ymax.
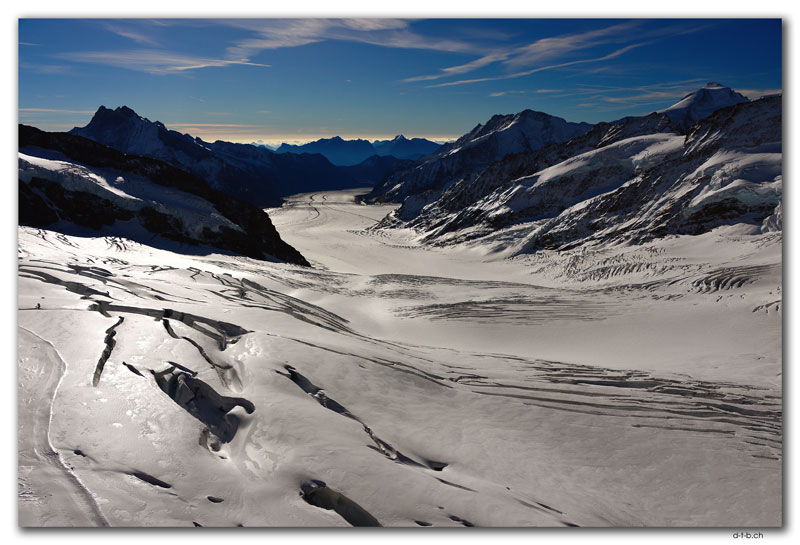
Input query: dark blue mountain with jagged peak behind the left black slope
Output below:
<box><xmin>70</xmin><ymin>106</ymin><xmax>354</xmax><ymax>207</ymax></box>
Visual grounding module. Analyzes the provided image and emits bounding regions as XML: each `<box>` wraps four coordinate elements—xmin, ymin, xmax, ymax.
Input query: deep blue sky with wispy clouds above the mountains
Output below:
<box><xmin>19</xmin><ymin>18</ymin><xmax>782</xmax><ymax>143</ymax></box>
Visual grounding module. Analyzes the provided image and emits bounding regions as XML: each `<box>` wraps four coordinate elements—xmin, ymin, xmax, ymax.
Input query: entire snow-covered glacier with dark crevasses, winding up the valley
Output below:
<box><xmin>18</xmin><ymin>191</ymin><xmax>782</xmax><ymax>527</ymax></box>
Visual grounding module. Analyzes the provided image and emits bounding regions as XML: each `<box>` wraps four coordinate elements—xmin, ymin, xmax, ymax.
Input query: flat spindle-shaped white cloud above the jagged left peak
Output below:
<box><xmin>57</xmin><ymin>49</ymin><xmax>269</xmax><ymax>74</ymax></box>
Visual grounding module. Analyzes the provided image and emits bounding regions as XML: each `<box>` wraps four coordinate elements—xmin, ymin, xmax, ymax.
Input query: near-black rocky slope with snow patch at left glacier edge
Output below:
<box><xmin>19</xmin><ymin>125</ymin><xmax>308</xmax><ymax>265</ymax></box>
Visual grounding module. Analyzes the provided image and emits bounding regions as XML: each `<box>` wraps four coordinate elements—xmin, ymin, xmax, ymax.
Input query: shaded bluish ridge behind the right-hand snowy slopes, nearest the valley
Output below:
<box><xmin>367</xmin><ymin>110</ymin><xmax>592</xmax><ymax>219</ymax></box>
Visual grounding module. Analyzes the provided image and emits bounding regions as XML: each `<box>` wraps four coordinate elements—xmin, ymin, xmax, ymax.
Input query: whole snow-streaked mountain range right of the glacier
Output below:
<box><xmin>365</xmin><ymin>83</ymin><xmax>782</xmax><ymax>254</ymax></box>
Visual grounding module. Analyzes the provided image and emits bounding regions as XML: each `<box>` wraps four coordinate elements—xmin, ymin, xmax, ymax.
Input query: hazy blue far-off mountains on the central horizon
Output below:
<box><xmin>275</xmin><ymin>134</ymin><xmax>441</xmax><ymax>166</ymax></box>
